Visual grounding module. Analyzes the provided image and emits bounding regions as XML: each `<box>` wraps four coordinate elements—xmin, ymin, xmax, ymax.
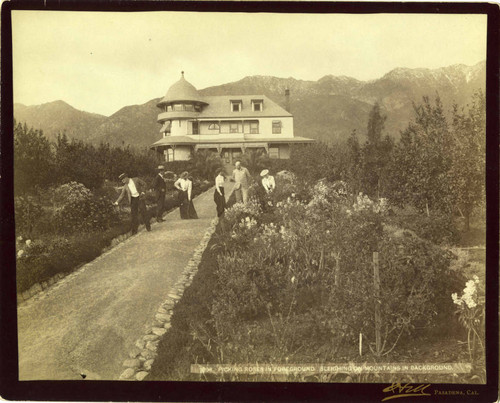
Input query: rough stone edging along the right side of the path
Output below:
<box><xmin>119</xmin><ymin>218</ymin><xmax>218</xmax><ymax>381</ymax></box>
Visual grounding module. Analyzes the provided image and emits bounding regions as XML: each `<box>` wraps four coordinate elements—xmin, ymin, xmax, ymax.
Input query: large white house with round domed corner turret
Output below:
<box><xmin>151</xmin><ymin>72</ymin><xmax>314</xmax><ymax>164</ymax></box>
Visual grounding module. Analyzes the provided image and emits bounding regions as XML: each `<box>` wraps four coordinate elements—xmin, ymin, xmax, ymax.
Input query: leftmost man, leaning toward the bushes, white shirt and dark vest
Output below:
<box><xmin>114</xmin><ymin>174</ymin><xmax>151</xmax><ymax>235</ymax></box>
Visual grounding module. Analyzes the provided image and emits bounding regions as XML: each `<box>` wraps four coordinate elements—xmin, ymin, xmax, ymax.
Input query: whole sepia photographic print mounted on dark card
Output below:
<box><xmin>4</xmin><ymin>2</ymin><xmax>498</xmax><ymax>401</ymax></box>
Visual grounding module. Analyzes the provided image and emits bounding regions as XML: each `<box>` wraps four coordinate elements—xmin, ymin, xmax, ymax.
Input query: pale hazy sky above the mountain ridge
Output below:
<box><xmin>12</xmin><ymin>11</ymin><xmax>486</xmax><ymax>115</ymax></box>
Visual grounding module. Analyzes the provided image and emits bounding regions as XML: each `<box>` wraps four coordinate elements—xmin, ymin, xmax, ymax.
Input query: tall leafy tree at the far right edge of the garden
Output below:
<box><xmin>449</xmin><ymin>92</ymin><xmax>486</xmax><ymax>231</ymax></box>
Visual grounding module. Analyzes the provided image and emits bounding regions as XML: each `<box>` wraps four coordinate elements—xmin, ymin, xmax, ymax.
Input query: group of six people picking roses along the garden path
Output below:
<box><xmin>114</xmin><ymin>161</ymin><xmax>276</xmax><ymax>234</ymax></box>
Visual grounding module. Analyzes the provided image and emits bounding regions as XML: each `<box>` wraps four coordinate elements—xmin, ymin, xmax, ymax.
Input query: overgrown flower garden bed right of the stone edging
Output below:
<box><xmin>148</xmin><ymin>178</ymin><xmax>485</xmax><ymax>383</ymax></box>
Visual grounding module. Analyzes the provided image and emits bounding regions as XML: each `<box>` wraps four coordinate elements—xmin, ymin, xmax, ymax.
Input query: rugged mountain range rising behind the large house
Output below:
<box><xmin>14</xmin><ymin>61</ymin><xmax>486</xmax><ymax>148</ymax></box>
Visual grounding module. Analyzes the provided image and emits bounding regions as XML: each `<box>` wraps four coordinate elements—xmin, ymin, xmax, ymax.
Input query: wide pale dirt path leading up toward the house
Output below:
<box><xmin>18</xmin><ymin>188</ymin><xmax>227</xmax><ymax>380</ymax></box>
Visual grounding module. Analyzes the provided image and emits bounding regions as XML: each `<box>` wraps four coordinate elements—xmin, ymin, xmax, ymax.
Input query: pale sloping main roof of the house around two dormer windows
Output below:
<box><xmin>198</xmin><ymin>95</ymin><xmax>292</xmax><ymax>119</ymax></box>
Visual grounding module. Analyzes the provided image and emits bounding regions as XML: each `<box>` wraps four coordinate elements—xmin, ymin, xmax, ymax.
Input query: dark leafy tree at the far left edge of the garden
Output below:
<box><xmin>14</xmin><ymin>121</ymin><xmax>55</xmax><ymax>195</ymax></box>
